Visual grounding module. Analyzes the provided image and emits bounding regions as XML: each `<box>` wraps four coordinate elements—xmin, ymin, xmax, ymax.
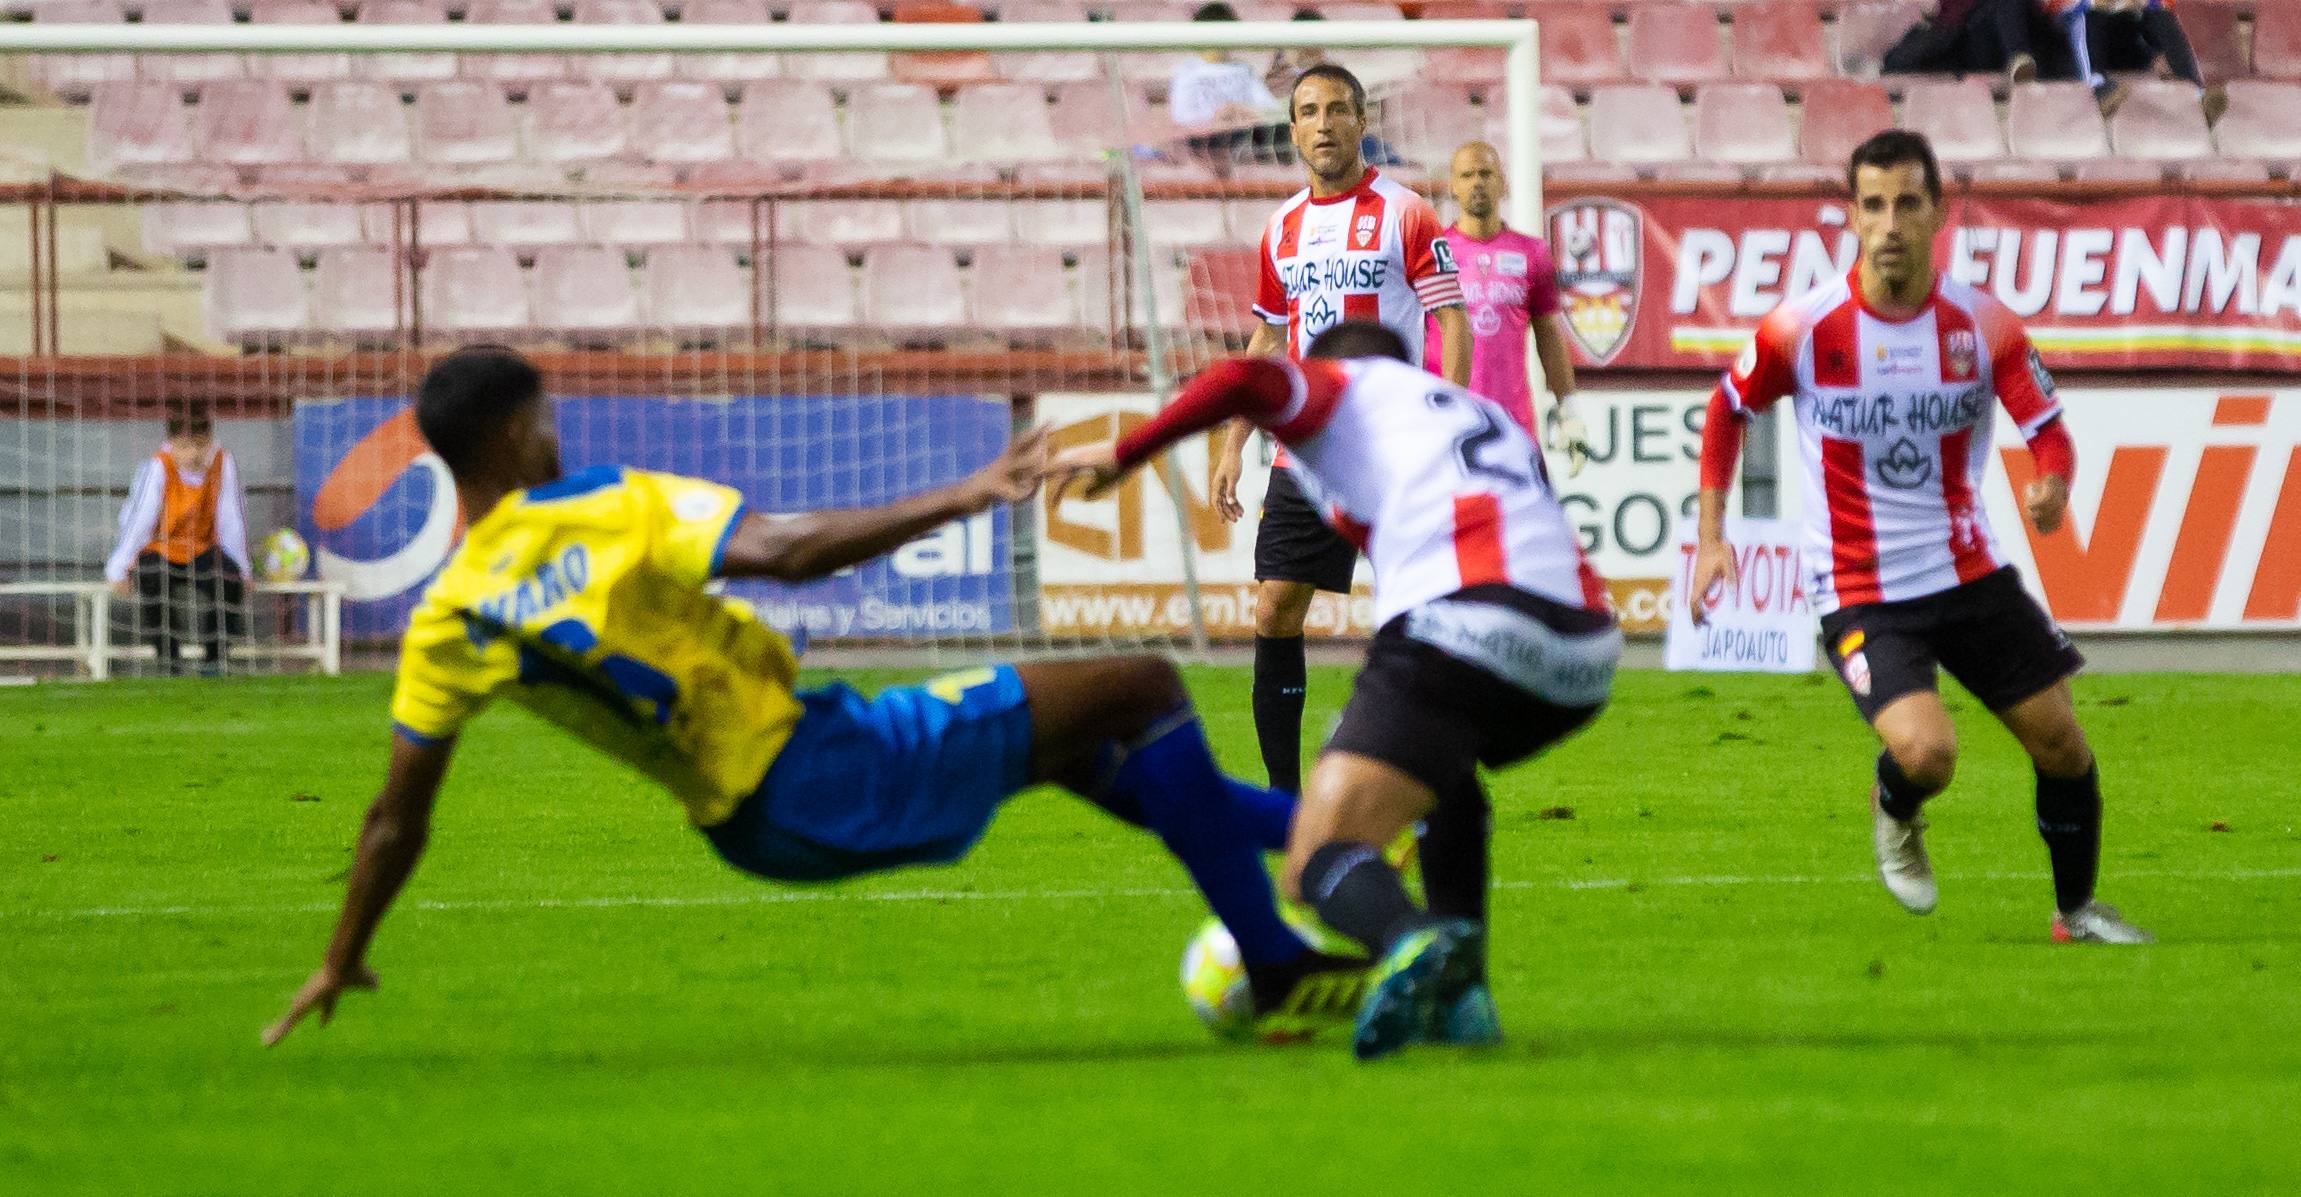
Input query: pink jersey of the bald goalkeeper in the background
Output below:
<box><xmin>1424</xmin><ymin>226</ymin><xmax>1558</xmax><ymax>440</ymax></box>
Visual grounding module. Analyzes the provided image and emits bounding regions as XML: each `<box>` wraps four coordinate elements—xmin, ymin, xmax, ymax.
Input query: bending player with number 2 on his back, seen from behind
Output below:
<box><xmin>1056</xmin><ymin>322</ymin><xmax>1622</xmax><ymax>1059</ymax></box>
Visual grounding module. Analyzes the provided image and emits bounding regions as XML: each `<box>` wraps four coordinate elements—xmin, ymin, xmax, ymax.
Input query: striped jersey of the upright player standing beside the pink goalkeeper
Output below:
<box><xmin>1254</xmin><ymin>168</ymin><xmax>1461</xmax><ymax>361</ymax></box>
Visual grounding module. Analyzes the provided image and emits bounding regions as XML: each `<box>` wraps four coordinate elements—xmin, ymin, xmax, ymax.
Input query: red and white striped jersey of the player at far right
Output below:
<box><xmin>1712</xmin><ymin>276</ymin><xmax>2062</xmax><ymax>612</ymax></box>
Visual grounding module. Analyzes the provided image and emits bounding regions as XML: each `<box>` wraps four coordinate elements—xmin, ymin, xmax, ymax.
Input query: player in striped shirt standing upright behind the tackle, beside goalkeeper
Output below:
<box><xmin>1213</xmin><ymin>62</ymin><xmax>1470</xmax><ymax>792</ymax></box>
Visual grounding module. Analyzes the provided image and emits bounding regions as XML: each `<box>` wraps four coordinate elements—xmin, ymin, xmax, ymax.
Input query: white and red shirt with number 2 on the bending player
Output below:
<box><xmin>1118</xmin><ymin>357</ymin><xmax>1608</xmax><ymax>626</ymax></box>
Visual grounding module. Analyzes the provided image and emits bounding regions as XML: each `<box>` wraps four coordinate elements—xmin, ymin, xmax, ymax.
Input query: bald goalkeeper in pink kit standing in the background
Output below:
<box><xmin>1427</xmin><ymin>140</ymin><xmax>1590</xmax><ymax>479</ymax></box>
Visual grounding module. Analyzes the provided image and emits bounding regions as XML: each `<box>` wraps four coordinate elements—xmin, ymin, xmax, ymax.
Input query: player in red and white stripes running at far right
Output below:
<box><xmin>1694</xmin><ymin>129</ymin><xmax>2149</xmax><ymax>944</ymax></box>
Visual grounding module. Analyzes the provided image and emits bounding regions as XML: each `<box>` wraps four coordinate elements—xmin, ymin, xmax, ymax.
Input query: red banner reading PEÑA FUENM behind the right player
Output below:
<box><xmin>1546</xmin><ymin>196</ymin><xmax>2301</xmax><ymax>373</ymax></box>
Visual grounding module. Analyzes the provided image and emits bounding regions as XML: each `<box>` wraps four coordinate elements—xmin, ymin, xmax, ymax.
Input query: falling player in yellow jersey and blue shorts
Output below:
<box><xmin>265</xmin><ymin>348</ymin><xmax>1364</xmax><ymax>1043</ymax></box>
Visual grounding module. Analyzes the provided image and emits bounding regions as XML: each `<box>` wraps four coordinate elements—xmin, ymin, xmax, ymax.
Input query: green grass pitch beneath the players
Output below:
<box><xmin>0</xmin><ymin>670</ymin><xmax>2301</xmax><ymax>1195</ymax></box>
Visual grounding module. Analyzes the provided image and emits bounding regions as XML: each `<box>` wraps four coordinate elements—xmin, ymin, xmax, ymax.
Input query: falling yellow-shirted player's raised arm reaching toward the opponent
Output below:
<box><xmin>718</xmin><ymin>428</ymin><xmax>1047</xmax><ymax>582</ymax></box>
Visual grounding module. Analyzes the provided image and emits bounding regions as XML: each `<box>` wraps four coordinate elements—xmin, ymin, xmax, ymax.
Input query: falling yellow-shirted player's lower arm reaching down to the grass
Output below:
<box><xmin>265</xmin><ymin>734</ymin><xmax>456</xmax><ymax>1047</ymax></box>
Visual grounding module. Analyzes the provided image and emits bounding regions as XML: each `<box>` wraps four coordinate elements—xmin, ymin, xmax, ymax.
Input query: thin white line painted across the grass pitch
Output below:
<box><xmin>17</xmin><ymin>868</ymin><xmax>2301</xmax><ymax>918</ymax></box>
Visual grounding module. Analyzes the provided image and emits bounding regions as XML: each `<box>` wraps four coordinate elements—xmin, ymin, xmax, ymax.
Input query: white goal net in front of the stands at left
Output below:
<box><xmin>0</xmin><ymin>14</ymin><xmax>1535</xmax><ymax>677</ymax></box>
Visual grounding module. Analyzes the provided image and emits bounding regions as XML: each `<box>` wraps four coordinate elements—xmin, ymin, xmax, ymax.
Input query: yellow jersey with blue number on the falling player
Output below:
<box><xmin>391</xmin><ymin>467</ymin><xmax>798</xmax><ymax>826</ymax></box>
